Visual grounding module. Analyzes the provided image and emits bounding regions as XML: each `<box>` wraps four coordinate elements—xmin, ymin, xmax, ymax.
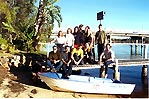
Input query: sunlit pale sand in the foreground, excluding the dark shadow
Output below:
<box><xmin>0</xmin><ymin>78</ymin><xmax>122</xmax><ymax>98</ymax></box>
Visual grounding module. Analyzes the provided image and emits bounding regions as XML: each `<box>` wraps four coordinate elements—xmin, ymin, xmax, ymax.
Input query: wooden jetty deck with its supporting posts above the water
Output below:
<box><xmin>72</xmin><ymin>59</ymin><xmax>149</xmax><ymax>80</ymax></box>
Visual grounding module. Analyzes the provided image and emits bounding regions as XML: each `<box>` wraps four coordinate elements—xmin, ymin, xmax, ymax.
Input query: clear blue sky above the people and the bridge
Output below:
<box><xmin>36</xmin><ymin>0</ymin><xmax>149</xmax><ymax>32</ymax></box>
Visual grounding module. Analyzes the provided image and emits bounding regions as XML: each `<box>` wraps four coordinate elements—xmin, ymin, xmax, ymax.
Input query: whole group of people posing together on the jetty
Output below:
<box><xmin>47</xmin><ymin>24</ymin><xmax>115</xmax><ymax>79</ymax></box>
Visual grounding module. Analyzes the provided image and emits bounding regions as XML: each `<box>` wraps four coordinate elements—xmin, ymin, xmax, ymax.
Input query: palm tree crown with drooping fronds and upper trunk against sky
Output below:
<box><xmin>35</xmin><ymin>0</ymin><xmax>62</xmax><ymax>39</ymax></box>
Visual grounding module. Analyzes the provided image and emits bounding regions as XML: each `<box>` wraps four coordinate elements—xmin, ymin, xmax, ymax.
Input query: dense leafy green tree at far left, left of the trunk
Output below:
<box><xmin>0</xmin><ymin>0</ymin><xmax>37</xmax><ymax>50</ymax></box>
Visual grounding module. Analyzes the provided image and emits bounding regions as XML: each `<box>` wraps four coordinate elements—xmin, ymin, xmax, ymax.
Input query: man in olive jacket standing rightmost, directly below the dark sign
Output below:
<box><xmin>95</xmin><ymin>24</ymin><xmax>106</xmax><ymax>60</ymax></box>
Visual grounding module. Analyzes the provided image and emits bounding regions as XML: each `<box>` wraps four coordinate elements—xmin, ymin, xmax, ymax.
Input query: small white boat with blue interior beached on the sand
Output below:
<box><xmin>38</xmin><ymin>72</ymin><xmax>135</xmax><ymax>95</ymax></box>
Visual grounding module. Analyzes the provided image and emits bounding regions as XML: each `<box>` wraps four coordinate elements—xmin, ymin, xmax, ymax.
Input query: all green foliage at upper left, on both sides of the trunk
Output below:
<box><xmin>0</xmin><ymin>0</ymin><xmax>62</xmax><ymax>51</ymax></box>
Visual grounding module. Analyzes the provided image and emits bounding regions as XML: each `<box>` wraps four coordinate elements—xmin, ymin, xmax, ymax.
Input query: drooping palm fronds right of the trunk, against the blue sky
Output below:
<box><xmin>37</xmin><ymin>0</ymin><xmax>62</xmax><ymax>41</ymax></box>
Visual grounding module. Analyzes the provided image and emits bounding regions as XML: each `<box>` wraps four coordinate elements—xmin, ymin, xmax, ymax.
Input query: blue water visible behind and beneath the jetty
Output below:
<box><xmin>41</xmin><ymin>44</ymin><xmax>149</xmax><ymax>98</ymax></box>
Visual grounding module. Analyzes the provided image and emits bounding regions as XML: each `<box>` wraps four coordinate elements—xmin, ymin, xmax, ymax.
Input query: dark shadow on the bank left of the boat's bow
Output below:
<box><xmin>10</xmin><ymin>53</ymin><xmax>50</xmax><ymax>89</ymax></box>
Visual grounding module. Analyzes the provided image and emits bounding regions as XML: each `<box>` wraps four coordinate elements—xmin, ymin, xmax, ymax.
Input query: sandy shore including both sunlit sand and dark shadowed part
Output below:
<box><xmin>0</xmin><ymin>66</ymin><xmax>120</xmax><ymax>98</ymax></box>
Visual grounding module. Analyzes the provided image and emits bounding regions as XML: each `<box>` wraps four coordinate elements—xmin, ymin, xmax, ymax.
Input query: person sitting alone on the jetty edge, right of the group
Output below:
<box><xmin>99</xmin><ymin>43</ymin><xmax>115</xmax><ymax>75</ymax></box>
